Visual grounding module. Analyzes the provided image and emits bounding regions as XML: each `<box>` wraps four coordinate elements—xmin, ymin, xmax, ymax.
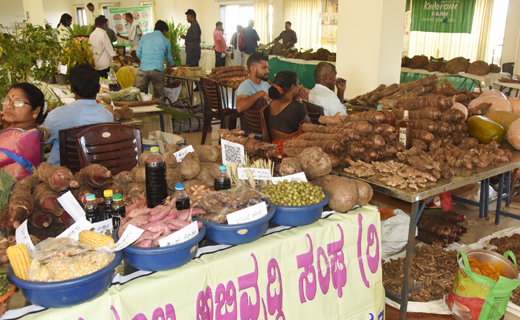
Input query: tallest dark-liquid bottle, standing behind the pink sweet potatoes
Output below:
<box><xmin>145</xmin><ymin>147</ymin><xmax>168</xmax><ymax>208</ymax></box>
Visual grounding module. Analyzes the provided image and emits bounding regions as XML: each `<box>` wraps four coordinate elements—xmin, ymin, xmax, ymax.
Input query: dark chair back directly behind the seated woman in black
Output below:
<box><xmin>240</xmin><ymin>98</ymin><xmax>271</xmax><ymax>143</ymax></box>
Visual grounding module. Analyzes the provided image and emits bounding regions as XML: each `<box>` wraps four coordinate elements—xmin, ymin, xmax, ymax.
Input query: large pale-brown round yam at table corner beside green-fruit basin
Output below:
<box><xmin>314</xmin><ymin>175</ymin><xmax>358</xmax><ymax>212</ymax></box>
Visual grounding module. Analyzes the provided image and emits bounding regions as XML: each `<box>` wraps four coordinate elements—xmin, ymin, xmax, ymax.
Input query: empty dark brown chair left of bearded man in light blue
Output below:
<box><xmin>200</xmin><ymin>78</ymin><xmax>239</xmax><ymax>144</ymax></box>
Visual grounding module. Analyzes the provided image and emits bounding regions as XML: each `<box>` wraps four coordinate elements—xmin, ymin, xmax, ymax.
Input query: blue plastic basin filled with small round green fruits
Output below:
<box><xmin>272</xmin><ymin>190</ymin><xmax>330</xmax><ymax>227</ymax></box>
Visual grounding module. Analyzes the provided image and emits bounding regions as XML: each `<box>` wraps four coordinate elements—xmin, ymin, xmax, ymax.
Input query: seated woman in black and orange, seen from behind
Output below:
<box><xmin>267</xmin><ymin>70</ymin><xmax>311</xmax><ymax>141</ymax></box>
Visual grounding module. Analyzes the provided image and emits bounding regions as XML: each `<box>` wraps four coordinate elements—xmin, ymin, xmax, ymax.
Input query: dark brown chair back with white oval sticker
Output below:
<box><xmin>76</xmin><ymin>124</ymin><xmax>143</xmax><ymax>175</ymax></box>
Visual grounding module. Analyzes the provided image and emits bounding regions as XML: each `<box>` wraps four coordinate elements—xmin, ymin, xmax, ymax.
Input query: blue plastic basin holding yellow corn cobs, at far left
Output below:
<box><xmin>7</xmin><ymin>252</ymin><xmax>122</xmax><ymax>308</ymax></box>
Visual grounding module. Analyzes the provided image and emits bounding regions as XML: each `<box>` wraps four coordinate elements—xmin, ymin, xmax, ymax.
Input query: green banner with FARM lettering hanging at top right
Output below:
<box><xmin>410</xmin><ymin>0</ymin><xmax>476</xmax><ymax>33</ymax></box>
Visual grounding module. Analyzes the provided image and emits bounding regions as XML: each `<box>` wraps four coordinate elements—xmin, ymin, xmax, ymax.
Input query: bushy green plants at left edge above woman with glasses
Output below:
<box><xmin>0</xmin><ymin>23</ymin><xmax>61</xmax><ymax>97</ymax></box>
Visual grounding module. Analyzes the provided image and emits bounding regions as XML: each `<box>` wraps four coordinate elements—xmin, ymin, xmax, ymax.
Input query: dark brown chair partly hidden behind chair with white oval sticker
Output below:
<box><xmin>59</xmin><ymin>122</ymin><xmax>111</xmax><ymax>173</ymax></box>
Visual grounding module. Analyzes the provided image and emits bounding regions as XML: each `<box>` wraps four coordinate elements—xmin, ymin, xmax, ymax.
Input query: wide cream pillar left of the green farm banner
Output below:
<box><xmin>336</xmin><ymin>0</ymin><xmax>406</xmax><ymax>99</ymax></box>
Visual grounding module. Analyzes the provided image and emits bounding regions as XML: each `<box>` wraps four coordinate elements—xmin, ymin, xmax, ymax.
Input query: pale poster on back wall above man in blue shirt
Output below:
<box><xmin>107</xmin><ymin>6</ymin><xmax>154</xmax><ymax>36</ymax></box>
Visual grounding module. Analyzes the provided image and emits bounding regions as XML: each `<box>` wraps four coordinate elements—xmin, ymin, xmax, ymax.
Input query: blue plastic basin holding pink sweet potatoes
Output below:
<box><xmin>113</xmin><ymin>226</ymin><xmax>206</xmax><ymax>271</ymax></box>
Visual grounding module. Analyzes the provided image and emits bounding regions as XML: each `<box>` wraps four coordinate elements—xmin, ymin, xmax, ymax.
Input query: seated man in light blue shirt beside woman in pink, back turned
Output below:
<box><xmin>42</xmin><ymin>64</ymin><xmax>114</xmax><ymax>166</ymax></box>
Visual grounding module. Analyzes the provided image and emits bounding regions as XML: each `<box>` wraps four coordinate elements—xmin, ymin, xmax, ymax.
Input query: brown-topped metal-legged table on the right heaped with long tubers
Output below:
<box><xmin>333</xmin><ymin>150</ymin><xmax>520</xmax><ymax>319</ymax></box>
